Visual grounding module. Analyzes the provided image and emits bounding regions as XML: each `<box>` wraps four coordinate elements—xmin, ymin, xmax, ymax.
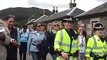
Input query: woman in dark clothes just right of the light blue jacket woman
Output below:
<box><xmin>40</xmin><ymin>23</ymin><xmax>49</xmax><ymax>60</ymax></box>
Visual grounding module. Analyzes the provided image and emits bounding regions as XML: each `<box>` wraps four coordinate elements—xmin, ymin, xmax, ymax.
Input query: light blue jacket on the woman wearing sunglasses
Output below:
<box><xmin>27</xmin><ymin>31</ymin><xmax>45</xmax><ymax>52</ymax></box>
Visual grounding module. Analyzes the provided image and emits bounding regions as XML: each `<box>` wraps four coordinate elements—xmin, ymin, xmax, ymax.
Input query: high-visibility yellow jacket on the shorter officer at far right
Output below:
<box><xmin>85</xmin><ymin>35</ymin><xmax>107</xmax><ymax>58</ymax></box>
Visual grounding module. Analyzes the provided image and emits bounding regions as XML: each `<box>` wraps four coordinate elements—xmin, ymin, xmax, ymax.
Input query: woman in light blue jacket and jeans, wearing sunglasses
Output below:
<box><xmin>27</xmin><ymin>23</ymin><xmax>45</xmax><ymax>60</ymax></box>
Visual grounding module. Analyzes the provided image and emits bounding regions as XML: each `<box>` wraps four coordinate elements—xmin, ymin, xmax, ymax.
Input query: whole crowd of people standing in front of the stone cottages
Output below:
<box><xmin>0</xmin><ymin>15</ymin><xmax>107</xmax><ymax>60</ymax></box>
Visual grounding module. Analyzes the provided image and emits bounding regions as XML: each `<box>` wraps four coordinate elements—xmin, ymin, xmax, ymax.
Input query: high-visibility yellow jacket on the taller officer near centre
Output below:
<box><xmin>54</xmin><ymin>29</ymin><xmax>79</xmax><ymax>54</ymax></box>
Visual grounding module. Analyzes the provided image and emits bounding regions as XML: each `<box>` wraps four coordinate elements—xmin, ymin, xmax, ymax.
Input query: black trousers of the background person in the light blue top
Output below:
<box><xmin>19</xmin><ymin>42</ymin><xmax>27</xmax><ymax>60</ymax></box>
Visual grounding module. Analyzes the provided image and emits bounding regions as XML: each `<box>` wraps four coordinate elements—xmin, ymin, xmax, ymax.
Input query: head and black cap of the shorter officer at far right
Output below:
<box><xmin>93</xmin><ymin>23</ymin><xmax>104</xmax><ymax>37</ymax></box>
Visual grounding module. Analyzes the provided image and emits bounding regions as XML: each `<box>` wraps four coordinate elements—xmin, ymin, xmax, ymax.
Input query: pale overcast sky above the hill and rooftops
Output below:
<box><xmin>0</xmin><ymin>0</ymin><xmax>106</xmax><ymax>11</ymax></box>
